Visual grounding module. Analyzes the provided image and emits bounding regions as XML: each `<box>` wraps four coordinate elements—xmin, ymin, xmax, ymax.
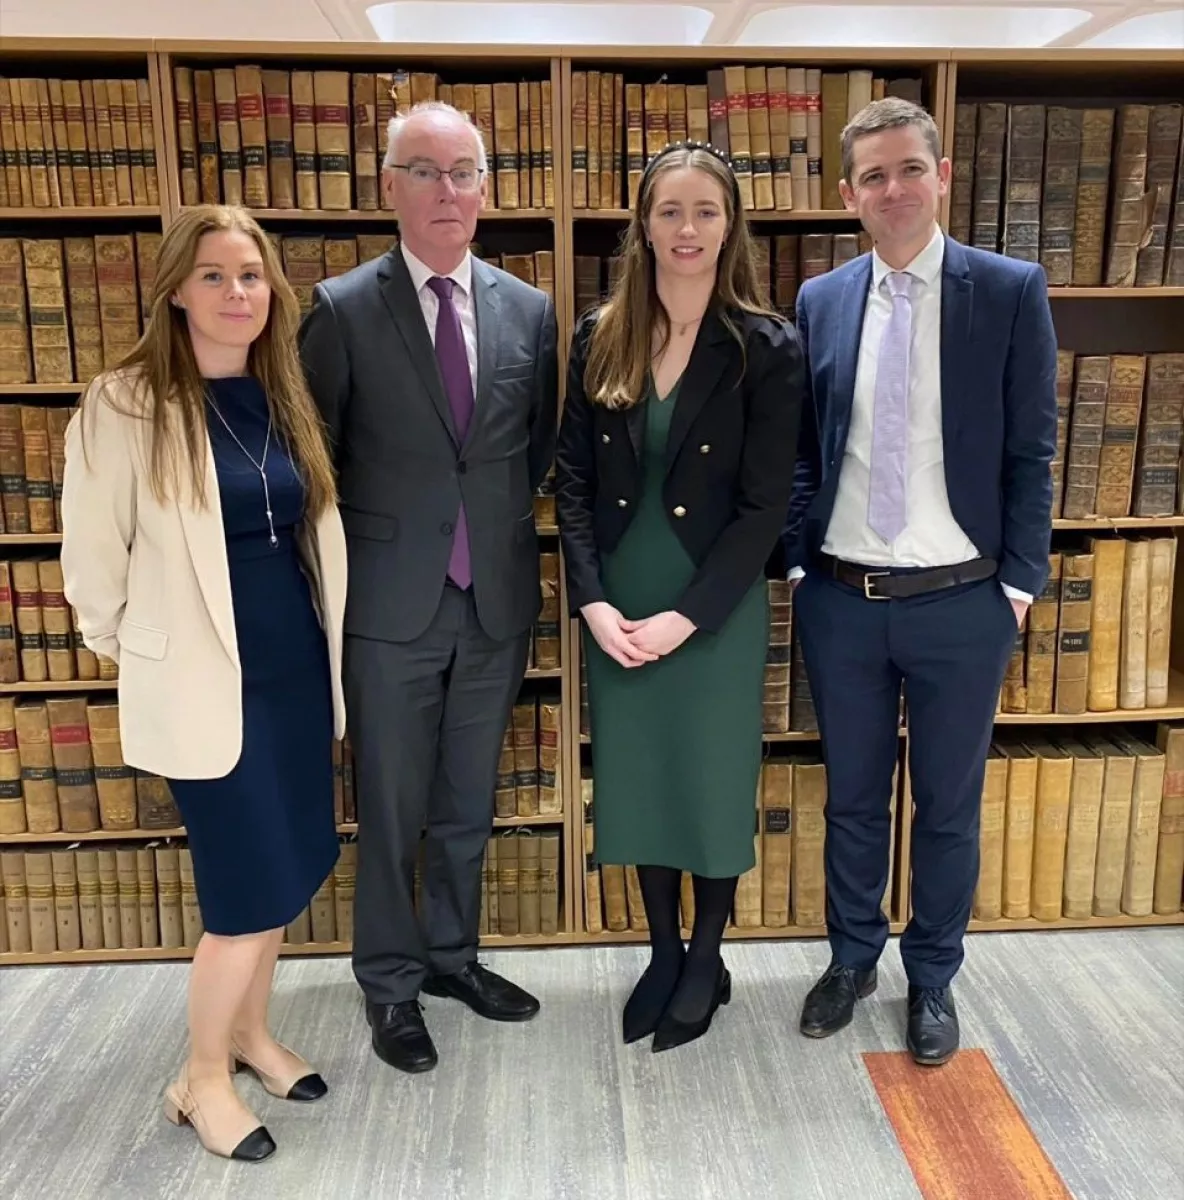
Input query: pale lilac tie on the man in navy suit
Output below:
<box><xmin>867</xmin><ymin>271</ymin><xmax>913</xmax><ymax>542</ymax></box>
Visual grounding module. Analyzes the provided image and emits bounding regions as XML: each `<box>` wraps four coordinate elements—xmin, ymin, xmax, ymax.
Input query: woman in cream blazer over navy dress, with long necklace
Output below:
<box><xmin>61</xmin><ymin>205</ymin><xmax>345</xmax><ymax>1162</ymax></box>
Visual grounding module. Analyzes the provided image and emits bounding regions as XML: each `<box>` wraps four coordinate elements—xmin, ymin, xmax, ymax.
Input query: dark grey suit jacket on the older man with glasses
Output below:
<box><xmin>300</xmin><ymin>246</ymin><xmax>558</xmax><ymax>642</ymax></box>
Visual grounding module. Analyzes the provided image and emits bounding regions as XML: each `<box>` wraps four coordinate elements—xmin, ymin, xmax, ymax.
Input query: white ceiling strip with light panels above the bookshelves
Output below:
<box><xmin>0</xmin><ymin>0</ymin><xmax>1184</xmax><ymax>47</ymax></box>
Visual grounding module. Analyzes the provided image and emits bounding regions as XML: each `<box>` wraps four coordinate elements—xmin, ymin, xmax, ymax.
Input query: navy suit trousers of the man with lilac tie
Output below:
<box><xmin>793</xmin><ymin>568</ymin><xmax>1016</xmax><ymax>988</ymax></box>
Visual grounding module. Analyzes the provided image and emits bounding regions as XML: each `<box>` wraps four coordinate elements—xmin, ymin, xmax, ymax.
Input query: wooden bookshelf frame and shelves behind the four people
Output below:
<box><xmin>0</xmin><ymin>37</ymin><xmax>1184</xmax><ymax>965</ymax></box>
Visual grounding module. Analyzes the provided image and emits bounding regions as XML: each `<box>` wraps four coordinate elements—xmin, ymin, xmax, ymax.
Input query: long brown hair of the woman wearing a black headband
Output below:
<box><xmin>584</xmin><ymin>146</ymin><xmax>777</xmax><ymax>408</ymax></box>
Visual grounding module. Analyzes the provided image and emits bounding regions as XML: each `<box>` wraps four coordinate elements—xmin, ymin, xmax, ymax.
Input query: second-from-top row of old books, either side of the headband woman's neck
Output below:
<box><xmin>575</xmin><ymin>233</ymin><xmax>872</xmax><ymax>318</ymax></box>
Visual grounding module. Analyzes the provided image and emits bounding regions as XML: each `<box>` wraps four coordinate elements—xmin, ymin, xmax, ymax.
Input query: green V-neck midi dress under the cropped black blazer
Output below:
<box><xmin>583</xmin><ymin>380</ymin><xmax>769</xmax><ymax>877</ymax></box>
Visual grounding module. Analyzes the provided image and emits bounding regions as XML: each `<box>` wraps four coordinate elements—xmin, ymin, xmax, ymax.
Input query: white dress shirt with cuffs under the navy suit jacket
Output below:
<box><xmin>789</xmin><ymin>228</ymin><xmax>1032</xmax><ymax>602</ymax></box>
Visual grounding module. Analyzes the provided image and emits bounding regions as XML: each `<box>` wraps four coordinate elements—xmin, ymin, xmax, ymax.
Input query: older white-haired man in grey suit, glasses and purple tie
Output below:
<box><xmin>301</xmin><ymin>103</ymin><xmax>558</xmax><ymax>1072</ymax></box>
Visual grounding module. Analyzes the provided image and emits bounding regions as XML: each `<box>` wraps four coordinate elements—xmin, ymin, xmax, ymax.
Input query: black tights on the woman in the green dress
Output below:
<box><xmin>637</xmin><ymin>866</ymin><xmax>737</xmax><ymax>1021</ymax></box>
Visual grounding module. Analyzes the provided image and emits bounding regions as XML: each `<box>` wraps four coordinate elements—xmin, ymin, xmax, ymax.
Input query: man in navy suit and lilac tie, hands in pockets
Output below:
<box><xmin>783</xmin><ymin>98</ymin><xmax>1057</xmax><ymax>1064</ymax></box>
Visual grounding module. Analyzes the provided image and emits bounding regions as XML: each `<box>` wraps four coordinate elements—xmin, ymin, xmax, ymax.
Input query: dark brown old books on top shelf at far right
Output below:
<box><xmin>950</xmin><ymin>98</ymin><xmax>1184</xmax><ymax>288</ymax></box>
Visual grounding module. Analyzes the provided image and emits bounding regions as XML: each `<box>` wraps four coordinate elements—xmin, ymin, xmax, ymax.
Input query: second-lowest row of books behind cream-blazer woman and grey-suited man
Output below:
<box><xmin>0</xmin><ymin>689</ymin><xmax>563</xmax><ymax>838</ymax></box>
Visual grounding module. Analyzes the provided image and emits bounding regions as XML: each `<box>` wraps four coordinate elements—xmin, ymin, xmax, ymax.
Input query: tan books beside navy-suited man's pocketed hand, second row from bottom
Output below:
<box><xmin>998</xmin><ymin>534</ymin><xmax>1177</xmax><ymax>715</ymax></box>
